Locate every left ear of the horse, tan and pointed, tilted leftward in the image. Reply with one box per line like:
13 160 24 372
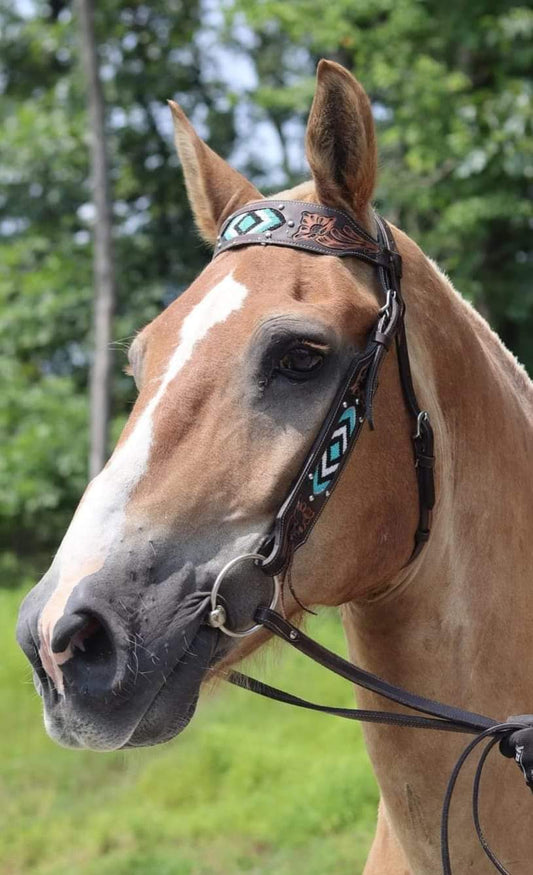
168 100 262 244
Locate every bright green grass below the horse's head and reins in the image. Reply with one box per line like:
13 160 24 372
0 590 377 875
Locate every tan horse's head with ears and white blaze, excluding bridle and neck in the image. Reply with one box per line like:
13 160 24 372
18 62 425 750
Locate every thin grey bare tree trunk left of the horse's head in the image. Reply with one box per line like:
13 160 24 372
78 0 115 478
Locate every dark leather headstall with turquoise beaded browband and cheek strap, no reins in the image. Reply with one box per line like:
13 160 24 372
215 200 435 576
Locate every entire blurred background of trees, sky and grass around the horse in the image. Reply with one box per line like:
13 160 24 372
0 0 533 875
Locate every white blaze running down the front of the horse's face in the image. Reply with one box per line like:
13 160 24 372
39 273 248 692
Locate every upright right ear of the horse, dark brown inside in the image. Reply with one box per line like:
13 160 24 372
306 61 377 215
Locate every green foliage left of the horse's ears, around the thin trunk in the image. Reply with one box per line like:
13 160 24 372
0 0 234 576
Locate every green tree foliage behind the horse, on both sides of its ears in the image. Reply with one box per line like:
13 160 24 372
0 0 533 576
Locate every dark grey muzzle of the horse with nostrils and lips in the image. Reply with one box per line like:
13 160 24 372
17 566 220 750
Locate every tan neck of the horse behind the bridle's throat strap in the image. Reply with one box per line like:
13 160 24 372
344 252 533 872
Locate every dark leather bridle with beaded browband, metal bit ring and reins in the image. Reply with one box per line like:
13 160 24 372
207 200 533 875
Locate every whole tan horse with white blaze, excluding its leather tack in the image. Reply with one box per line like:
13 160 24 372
18 60 533 875
